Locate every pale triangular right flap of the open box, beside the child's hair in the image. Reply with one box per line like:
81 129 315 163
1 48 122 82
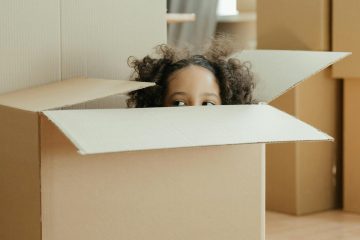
233 50 350 103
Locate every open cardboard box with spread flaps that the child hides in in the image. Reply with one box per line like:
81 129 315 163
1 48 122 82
0 50 347 240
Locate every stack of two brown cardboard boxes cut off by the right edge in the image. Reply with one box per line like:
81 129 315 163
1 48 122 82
332 0 360 213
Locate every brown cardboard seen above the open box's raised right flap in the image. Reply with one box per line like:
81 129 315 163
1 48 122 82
257 0 330 51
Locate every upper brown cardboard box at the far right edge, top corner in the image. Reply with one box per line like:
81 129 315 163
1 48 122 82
332 0 360 78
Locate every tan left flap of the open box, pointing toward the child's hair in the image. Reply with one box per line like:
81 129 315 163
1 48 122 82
0 78 154 112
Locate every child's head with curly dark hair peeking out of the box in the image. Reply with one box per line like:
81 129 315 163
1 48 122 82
128 36 254 107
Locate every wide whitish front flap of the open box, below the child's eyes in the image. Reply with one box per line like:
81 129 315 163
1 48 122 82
44 105 331 154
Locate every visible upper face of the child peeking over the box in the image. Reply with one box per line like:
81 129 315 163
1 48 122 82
164 65 221 107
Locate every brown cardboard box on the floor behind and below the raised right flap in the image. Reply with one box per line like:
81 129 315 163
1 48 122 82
266 69 341 215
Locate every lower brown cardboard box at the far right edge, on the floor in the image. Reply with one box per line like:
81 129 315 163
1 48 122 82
344 79 360 213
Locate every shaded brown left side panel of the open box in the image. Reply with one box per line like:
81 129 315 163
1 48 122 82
0 106 41 240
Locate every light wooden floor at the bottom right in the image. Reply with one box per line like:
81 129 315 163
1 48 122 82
266 211 360 240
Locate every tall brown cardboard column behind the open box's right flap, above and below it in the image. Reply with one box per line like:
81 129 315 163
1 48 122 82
257 0 341 215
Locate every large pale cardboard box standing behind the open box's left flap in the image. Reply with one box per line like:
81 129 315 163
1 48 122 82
0 0 167 109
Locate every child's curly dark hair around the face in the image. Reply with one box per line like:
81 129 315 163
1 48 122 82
127 35 255 107
